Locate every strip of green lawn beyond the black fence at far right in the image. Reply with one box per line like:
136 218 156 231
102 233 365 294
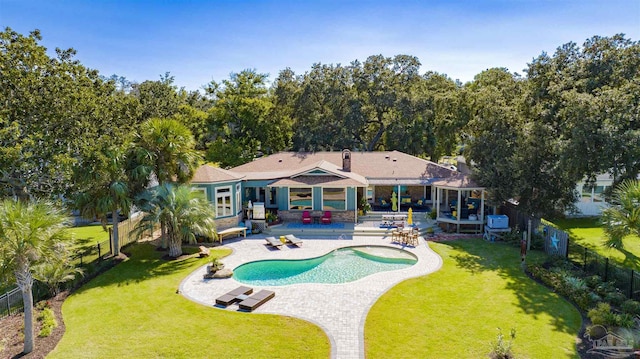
551 217 640 271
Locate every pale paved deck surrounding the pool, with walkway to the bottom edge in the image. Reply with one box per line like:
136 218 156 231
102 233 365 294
180 235 442 359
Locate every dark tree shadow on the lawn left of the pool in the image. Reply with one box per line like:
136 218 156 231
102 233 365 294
70 243 210 294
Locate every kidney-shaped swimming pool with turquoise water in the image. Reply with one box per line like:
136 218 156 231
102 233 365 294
233 246 418 286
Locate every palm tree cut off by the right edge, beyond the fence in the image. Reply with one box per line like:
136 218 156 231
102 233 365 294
602 180 640 249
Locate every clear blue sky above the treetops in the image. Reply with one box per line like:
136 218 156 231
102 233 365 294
0 0 640 90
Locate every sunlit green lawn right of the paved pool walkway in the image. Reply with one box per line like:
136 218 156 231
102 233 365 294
365 239 582 358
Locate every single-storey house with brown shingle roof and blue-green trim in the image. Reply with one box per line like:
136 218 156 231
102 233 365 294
192 150 484 229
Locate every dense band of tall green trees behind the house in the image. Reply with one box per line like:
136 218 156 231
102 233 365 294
0 28 640 215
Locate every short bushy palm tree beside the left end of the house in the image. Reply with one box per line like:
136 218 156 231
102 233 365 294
136 183 216 258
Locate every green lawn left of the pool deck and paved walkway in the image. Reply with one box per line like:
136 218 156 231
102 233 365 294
49 244 331 358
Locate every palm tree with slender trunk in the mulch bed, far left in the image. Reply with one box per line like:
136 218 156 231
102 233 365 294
0 199 69 354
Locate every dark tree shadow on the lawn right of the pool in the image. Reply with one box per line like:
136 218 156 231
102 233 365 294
445 239 580 334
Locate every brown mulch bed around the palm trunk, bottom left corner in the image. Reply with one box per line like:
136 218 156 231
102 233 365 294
0 292 68 359
